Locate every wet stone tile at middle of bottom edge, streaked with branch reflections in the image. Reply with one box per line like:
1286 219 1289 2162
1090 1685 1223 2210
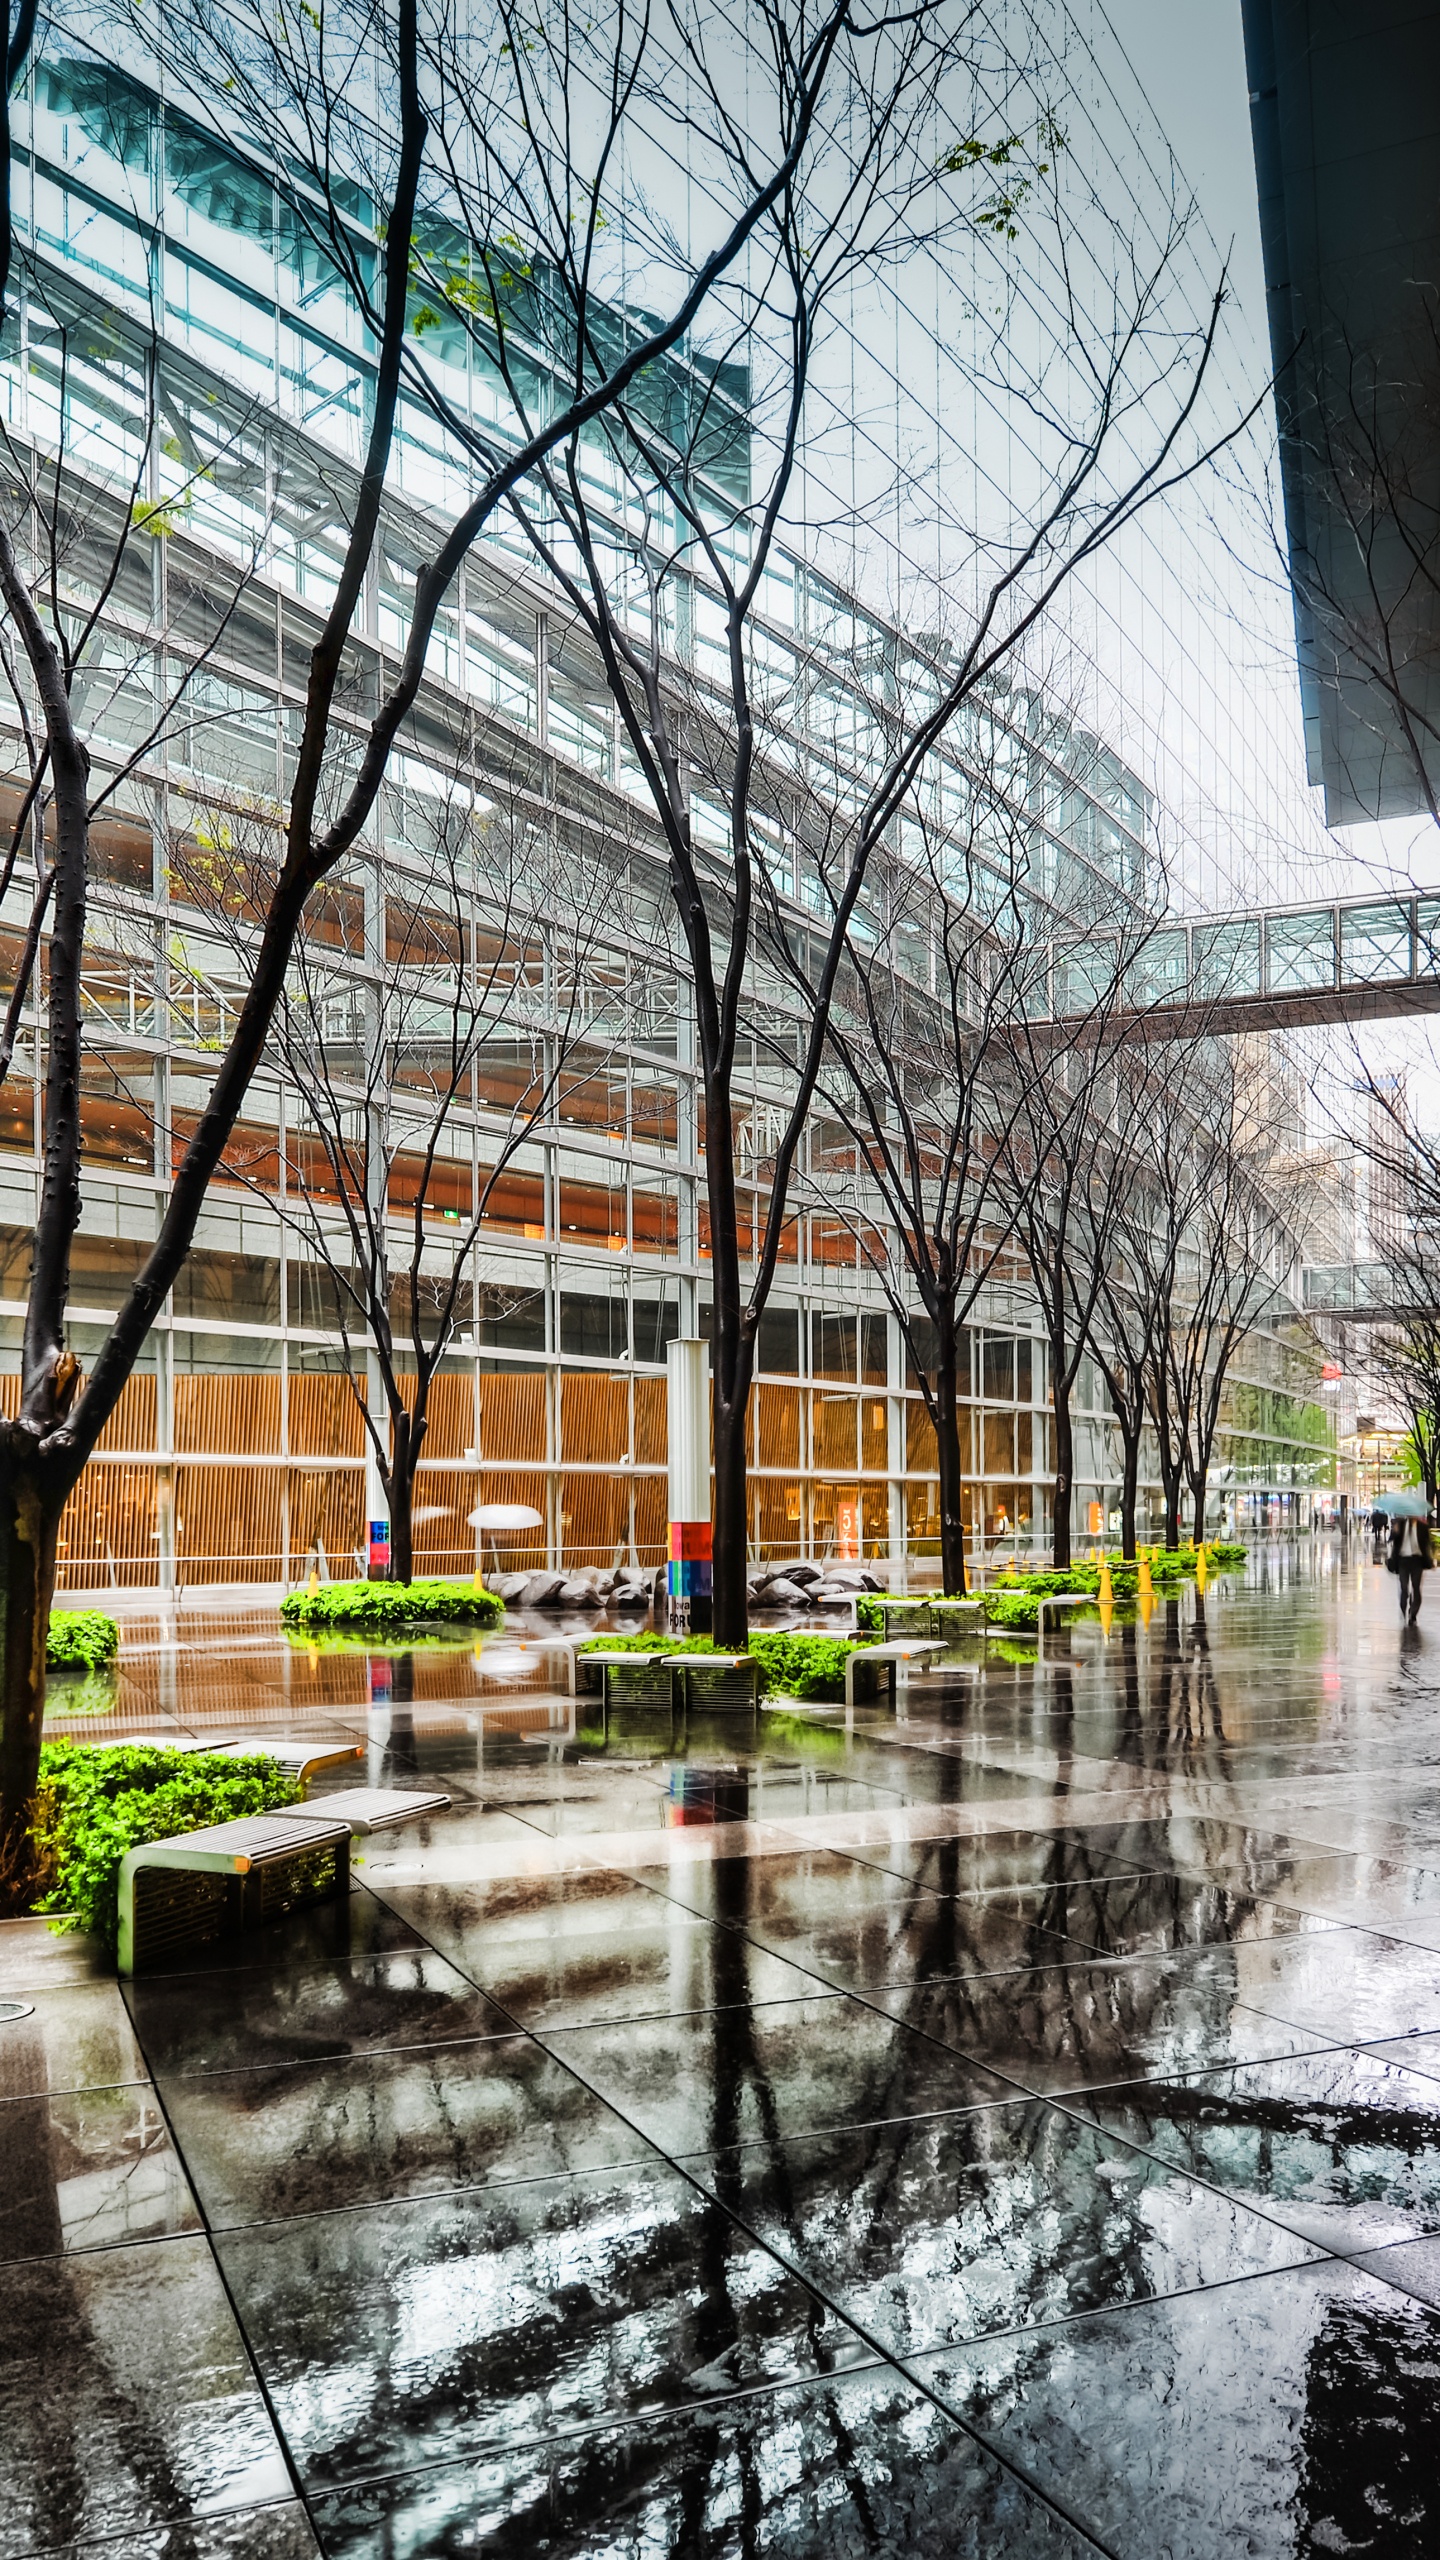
304 2365 1092 2560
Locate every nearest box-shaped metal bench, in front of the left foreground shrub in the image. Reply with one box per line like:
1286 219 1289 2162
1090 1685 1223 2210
118 1807 351 1974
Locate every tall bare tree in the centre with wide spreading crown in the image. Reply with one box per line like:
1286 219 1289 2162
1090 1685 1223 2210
368 0 1245 1644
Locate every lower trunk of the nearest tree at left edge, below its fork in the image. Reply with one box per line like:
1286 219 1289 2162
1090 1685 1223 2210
0 1454 69 1876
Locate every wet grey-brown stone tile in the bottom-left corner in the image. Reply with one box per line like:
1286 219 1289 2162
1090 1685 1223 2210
0 2237 292 2552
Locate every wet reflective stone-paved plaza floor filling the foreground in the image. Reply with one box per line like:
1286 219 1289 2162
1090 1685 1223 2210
0 1544 1440 2560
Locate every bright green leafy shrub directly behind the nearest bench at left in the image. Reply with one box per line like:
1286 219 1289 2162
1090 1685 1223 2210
31 1743 300 1946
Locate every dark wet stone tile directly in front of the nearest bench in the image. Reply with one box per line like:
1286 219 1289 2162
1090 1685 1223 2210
126 1948 507 2079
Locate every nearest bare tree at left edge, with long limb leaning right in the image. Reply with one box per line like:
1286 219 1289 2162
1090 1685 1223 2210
0 0 860 1884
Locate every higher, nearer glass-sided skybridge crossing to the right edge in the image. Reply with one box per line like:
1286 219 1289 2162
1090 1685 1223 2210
1033 896 1440 1039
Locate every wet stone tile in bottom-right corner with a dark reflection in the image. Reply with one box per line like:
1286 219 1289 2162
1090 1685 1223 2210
915 2260 1440 2560
